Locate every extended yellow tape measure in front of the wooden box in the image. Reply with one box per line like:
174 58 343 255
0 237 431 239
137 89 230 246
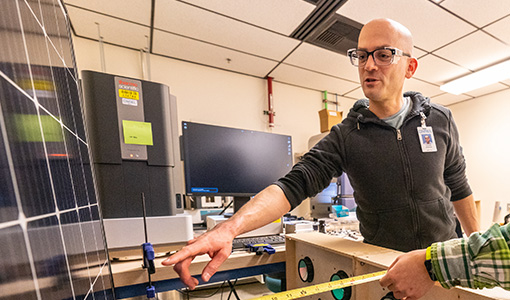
252 271 387 300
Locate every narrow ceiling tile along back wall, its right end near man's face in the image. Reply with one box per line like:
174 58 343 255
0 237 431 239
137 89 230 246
269 64 359 95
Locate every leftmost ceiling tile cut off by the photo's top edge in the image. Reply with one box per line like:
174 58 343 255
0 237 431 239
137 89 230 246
64 0 151 26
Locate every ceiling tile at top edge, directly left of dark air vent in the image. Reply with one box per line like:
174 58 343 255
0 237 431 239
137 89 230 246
178 0 315 36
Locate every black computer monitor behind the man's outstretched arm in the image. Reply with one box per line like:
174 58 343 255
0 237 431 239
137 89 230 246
181 122 292 197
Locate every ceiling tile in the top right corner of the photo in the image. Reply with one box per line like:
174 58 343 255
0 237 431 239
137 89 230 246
441 0 510 27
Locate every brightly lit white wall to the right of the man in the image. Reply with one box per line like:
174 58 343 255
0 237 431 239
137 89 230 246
449 89 510 229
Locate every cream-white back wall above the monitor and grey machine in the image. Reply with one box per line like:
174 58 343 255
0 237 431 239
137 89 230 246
73 37 352 215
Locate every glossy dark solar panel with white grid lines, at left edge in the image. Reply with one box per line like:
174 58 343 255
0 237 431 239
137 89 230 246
0 0 114 299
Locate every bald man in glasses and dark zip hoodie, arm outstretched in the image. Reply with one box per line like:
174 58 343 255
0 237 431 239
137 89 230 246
163 19 478 288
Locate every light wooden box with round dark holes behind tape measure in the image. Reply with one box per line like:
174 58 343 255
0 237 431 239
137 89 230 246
285 232 504 300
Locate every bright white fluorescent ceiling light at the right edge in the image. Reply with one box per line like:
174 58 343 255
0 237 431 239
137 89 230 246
439 60 510 95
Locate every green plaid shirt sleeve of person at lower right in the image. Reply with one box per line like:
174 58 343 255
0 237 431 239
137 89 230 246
430 224 510 290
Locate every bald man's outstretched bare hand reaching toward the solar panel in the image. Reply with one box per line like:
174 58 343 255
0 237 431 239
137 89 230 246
162 224 234 289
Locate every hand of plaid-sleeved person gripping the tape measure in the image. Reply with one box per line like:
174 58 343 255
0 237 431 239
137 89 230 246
379 250 434 300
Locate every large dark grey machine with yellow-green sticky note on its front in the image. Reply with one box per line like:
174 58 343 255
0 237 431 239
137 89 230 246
82 71 183 218
